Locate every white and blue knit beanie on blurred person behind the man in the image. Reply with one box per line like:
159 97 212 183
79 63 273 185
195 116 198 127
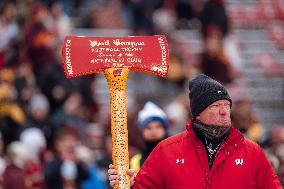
138 102 168 129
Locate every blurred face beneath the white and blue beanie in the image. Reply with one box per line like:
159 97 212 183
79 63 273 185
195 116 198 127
142 121 166 141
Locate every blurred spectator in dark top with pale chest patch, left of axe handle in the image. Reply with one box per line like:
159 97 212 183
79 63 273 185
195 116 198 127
44 128 89 189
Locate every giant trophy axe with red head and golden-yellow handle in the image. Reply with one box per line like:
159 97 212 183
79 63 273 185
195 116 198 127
62 35 169 189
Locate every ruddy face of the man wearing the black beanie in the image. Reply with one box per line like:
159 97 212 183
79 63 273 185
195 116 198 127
196 100 231 126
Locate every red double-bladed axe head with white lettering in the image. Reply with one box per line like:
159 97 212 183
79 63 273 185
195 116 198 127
62 35 169 78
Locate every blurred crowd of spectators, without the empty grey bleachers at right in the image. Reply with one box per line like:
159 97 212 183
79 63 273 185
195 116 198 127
0 0 284 189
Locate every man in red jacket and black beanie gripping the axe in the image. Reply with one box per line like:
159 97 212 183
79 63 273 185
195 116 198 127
109 75 282 189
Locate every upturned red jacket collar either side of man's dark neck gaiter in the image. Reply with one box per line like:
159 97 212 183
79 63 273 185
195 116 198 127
186 119 244 143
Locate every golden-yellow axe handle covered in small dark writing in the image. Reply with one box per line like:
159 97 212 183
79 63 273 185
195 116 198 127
104 68 130 189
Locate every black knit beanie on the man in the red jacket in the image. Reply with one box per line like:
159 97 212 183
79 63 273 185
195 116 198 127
189 74 232 117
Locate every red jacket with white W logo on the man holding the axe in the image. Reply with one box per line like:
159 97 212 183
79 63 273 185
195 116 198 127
133 122 282 189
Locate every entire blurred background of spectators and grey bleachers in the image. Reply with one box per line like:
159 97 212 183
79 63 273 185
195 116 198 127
0 0 284 189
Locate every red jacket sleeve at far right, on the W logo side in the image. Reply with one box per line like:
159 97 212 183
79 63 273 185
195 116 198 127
256 148 282 189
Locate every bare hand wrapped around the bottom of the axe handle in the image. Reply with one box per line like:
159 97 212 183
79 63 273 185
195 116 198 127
108 164 137 187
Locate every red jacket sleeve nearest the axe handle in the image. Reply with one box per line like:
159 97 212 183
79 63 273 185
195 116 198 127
133 145 165 189
